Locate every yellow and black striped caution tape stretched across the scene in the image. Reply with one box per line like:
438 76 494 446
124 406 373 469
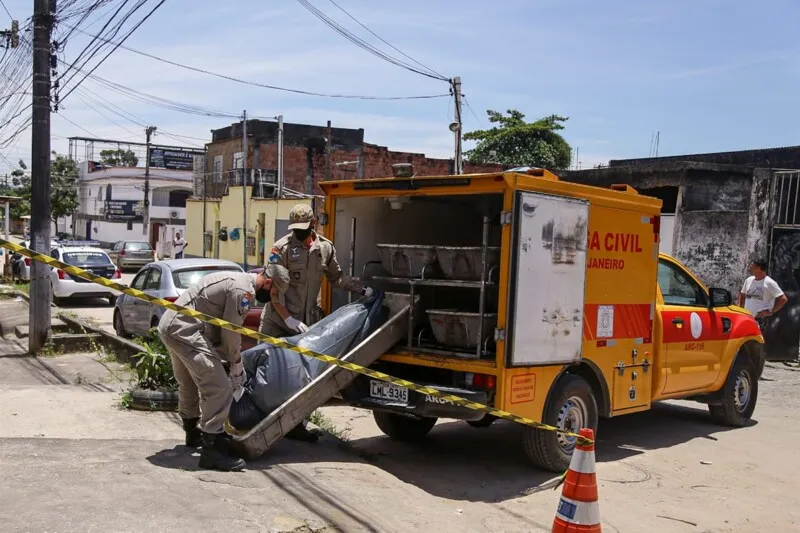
0 239 594 444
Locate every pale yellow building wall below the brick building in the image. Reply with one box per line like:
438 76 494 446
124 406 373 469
185 187 311 268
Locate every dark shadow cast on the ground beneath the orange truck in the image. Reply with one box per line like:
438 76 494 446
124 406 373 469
148 404 756 503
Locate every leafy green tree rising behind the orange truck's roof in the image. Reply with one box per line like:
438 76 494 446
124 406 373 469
464 109 572 170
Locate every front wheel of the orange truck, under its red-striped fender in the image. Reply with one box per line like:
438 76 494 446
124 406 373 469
708 360 758 427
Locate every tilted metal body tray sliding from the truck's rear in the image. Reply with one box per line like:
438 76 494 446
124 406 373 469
228 293 410 459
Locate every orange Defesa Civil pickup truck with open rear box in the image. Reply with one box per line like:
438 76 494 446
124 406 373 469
320 169 764 471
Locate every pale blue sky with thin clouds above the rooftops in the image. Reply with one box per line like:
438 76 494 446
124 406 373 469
0 0 800 171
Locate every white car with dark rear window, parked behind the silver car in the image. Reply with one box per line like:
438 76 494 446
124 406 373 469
50 246 122 306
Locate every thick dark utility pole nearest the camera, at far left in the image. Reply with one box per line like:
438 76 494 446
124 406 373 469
28 0 55 354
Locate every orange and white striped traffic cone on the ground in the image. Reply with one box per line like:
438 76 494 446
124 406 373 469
551 428 601 533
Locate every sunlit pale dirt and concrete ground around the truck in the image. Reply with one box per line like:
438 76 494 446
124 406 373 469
0 332 800 533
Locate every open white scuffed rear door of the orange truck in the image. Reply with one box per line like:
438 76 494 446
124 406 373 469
506 192 589 367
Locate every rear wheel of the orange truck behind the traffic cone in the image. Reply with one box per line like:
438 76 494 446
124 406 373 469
522 374 598 472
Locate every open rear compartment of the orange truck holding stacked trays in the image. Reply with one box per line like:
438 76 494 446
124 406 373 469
331 194 503 412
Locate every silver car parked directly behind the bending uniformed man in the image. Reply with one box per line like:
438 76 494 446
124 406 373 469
114 258 243 337
